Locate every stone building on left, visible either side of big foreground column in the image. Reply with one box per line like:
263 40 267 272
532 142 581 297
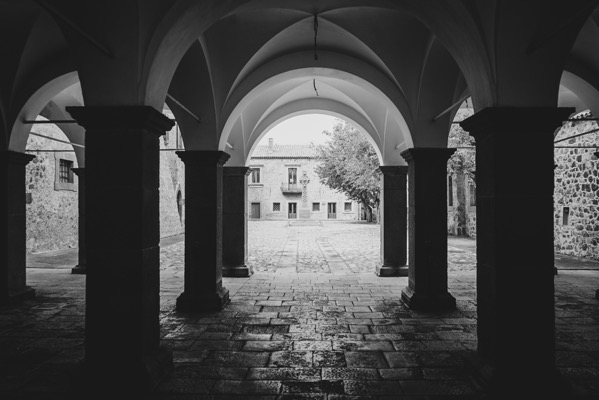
25 110 185 253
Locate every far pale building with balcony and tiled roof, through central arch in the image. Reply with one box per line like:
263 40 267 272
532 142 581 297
248 139 360 220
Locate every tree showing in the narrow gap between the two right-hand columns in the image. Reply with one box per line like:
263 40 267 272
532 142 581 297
447 109 476 236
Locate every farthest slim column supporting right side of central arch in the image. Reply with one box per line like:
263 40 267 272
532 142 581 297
375 166 408 276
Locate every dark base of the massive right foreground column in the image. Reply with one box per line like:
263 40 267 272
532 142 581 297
464 352 572 399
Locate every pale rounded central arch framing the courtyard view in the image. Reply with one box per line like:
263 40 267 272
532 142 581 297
219 68 413 165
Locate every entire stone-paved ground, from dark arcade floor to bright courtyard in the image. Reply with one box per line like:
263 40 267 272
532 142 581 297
0 221 599 400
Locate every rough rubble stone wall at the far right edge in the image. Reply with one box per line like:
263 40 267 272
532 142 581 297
554 112 599 259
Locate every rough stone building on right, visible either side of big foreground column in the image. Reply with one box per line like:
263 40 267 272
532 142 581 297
447 111 599 260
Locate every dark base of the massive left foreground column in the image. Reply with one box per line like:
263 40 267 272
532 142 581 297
73 346 174 395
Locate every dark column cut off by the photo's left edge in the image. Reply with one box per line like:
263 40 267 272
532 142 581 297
0 151 35 305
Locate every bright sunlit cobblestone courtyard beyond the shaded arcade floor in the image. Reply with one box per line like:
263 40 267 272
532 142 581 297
248 221 476 275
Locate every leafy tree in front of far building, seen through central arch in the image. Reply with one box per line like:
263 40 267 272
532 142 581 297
316 120 380 222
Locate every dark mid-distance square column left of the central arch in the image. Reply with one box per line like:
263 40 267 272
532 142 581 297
177 150 229 312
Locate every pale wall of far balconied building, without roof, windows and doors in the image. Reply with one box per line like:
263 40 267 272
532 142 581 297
248 158 359 220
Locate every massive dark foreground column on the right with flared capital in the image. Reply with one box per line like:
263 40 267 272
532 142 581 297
460 107 574 393
